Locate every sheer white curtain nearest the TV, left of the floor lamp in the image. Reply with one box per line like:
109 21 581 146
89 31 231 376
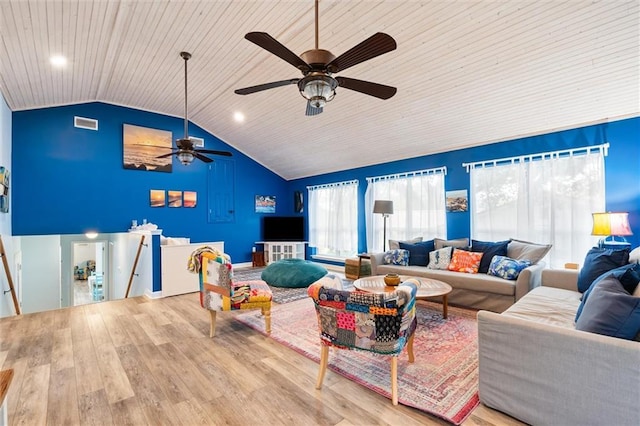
307 180 358 258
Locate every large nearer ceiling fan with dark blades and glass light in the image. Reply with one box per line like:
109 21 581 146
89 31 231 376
235 0 396 116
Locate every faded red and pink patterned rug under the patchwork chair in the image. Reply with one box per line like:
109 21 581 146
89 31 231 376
235 298 479 425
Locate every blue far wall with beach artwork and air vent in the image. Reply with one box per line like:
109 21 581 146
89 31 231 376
11 103 293 262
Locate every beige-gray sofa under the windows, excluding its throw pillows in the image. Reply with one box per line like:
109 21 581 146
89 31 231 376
371 239 549 313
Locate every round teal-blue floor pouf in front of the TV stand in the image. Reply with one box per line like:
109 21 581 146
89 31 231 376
262 259 327 288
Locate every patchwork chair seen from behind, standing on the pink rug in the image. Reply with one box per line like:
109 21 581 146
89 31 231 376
308 280 417 405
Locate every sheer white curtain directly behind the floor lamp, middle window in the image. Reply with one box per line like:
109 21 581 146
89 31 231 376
365 167 447 252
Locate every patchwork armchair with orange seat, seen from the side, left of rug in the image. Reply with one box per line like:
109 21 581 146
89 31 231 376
198 250 273 337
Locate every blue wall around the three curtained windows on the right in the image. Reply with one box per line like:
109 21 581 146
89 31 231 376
289 118 640 252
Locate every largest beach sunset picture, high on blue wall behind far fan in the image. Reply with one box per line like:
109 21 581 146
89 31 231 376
122 124 173 173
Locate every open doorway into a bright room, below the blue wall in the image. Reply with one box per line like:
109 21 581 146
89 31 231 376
71 241 109 306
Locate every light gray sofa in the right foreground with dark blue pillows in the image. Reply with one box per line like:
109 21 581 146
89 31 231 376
478 269 640 426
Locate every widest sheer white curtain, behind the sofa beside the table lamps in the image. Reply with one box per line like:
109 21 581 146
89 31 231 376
465 145 608 268
